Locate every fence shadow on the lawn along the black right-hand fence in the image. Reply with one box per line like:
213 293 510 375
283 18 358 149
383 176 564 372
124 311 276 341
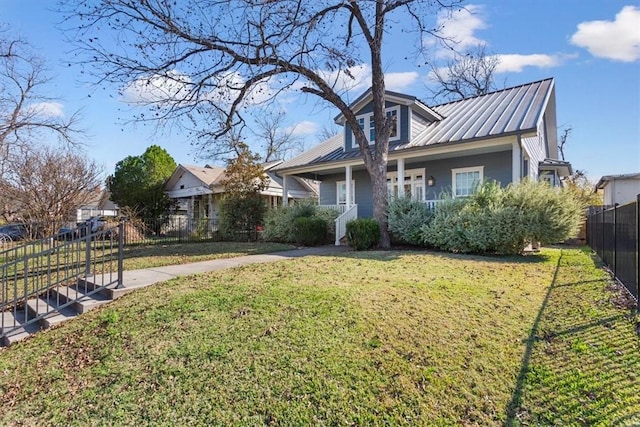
505 252 640 426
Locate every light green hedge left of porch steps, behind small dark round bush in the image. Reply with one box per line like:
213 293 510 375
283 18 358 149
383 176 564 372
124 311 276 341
262 201 339 243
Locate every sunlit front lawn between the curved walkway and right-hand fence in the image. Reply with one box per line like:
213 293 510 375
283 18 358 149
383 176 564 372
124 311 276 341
0 249 640 426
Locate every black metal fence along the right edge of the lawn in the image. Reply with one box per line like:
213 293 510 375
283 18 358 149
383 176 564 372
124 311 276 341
587 194 640 308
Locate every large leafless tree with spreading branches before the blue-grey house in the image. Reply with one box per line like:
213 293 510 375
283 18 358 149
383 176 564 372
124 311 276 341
63 0 460 247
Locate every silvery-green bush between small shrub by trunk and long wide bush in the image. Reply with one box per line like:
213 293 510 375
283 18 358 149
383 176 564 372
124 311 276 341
388 197 434 245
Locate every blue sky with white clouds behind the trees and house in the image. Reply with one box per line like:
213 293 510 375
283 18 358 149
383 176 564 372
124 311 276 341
0 0 640 181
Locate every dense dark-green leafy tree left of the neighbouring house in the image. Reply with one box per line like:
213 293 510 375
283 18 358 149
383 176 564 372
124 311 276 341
107 145 176 218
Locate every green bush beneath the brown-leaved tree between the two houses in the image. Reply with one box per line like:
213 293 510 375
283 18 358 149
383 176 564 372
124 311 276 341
219 195 267 241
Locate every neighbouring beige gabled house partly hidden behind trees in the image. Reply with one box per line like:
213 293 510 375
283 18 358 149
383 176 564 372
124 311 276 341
165 161 318 224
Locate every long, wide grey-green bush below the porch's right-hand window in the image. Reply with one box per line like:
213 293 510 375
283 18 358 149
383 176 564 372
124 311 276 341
420 180 582 254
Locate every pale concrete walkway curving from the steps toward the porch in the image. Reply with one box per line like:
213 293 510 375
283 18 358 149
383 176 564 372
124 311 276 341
110 246 351 298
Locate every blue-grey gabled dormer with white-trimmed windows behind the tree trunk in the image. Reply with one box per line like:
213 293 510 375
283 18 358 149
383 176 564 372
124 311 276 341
334 89 443 151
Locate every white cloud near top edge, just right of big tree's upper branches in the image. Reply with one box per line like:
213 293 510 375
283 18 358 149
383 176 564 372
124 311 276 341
437 4 487 54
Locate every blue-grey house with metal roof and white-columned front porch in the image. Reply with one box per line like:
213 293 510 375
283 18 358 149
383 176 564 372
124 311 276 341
274 79 572 244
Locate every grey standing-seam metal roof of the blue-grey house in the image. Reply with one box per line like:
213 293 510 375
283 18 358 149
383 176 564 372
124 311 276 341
274 79 554 170
